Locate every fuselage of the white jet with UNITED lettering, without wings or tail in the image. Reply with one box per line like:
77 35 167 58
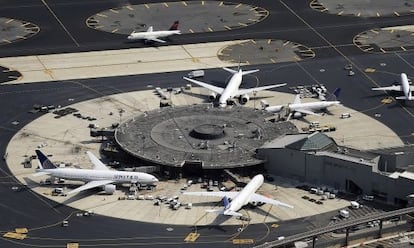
38 168 158 184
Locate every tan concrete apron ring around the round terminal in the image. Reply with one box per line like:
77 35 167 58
7 87 402 225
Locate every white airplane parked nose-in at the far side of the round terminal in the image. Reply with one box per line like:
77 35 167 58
184 68 286 107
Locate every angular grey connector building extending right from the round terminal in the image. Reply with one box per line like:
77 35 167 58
257 132 414 206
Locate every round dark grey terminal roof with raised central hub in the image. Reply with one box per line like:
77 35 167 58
115 104 298 169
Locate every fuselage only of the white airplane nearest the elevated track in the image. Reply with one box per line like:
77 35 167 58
224 174 264 215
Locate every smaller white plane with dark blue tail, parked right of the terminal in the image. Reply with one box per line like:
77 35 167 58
264 88 341 119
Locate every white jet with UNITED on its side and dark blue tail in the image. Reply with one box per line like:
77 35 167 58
35 150 158 194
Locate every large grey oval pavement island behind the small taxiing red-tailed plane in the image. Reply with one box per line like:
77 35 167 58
86 1 269 35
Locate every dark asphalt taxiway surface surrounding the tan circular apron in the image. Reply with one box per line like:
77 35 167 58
0 0 414 247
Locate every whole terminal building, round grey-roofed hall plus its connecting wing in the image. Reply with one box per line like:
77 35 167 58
115 104 414 206
